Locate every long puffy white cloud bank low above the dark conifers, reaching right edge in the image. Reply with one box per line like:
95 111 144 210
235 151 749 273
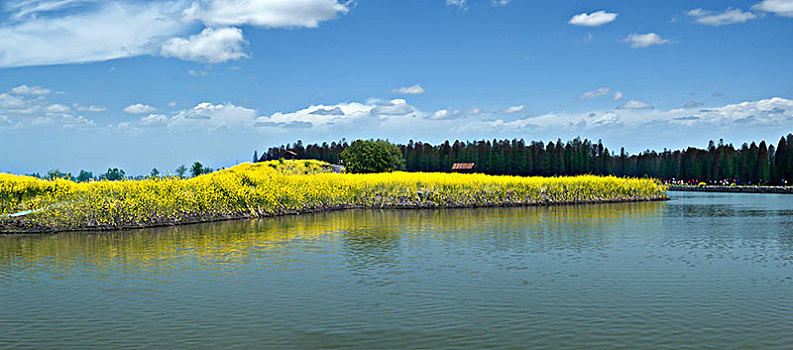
183 97 793 137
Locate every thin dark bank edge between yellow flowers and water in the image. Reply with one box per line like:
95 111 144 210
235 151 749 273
0 196 669 235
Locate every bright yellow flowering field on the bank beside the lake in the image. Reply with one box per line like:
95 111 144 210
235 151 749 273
0 160 668 233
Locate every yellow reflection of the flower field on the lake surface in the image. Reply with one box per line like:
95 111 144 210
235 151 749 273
0 202 664 270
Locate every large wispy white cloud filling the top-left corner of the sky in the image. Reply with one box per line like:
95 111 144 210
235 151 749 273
0 1 189 67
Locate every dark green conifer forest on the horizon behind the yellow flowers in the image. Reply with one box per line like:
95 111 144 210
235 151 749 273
254 134 793 185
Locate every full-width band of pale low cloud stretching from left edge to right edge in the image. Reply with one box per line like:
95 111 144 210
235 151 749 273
7 89 793 156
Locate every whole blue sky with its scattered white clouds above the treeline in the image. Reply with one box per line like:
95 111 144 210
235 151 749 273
0 0 793 174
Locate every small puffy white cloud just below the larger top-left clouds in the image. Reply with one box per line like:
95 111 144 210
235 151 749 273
160 28 248 63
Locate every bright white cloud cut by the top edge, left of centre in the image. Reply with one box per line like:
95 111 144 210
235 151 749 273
184 0 349 28
